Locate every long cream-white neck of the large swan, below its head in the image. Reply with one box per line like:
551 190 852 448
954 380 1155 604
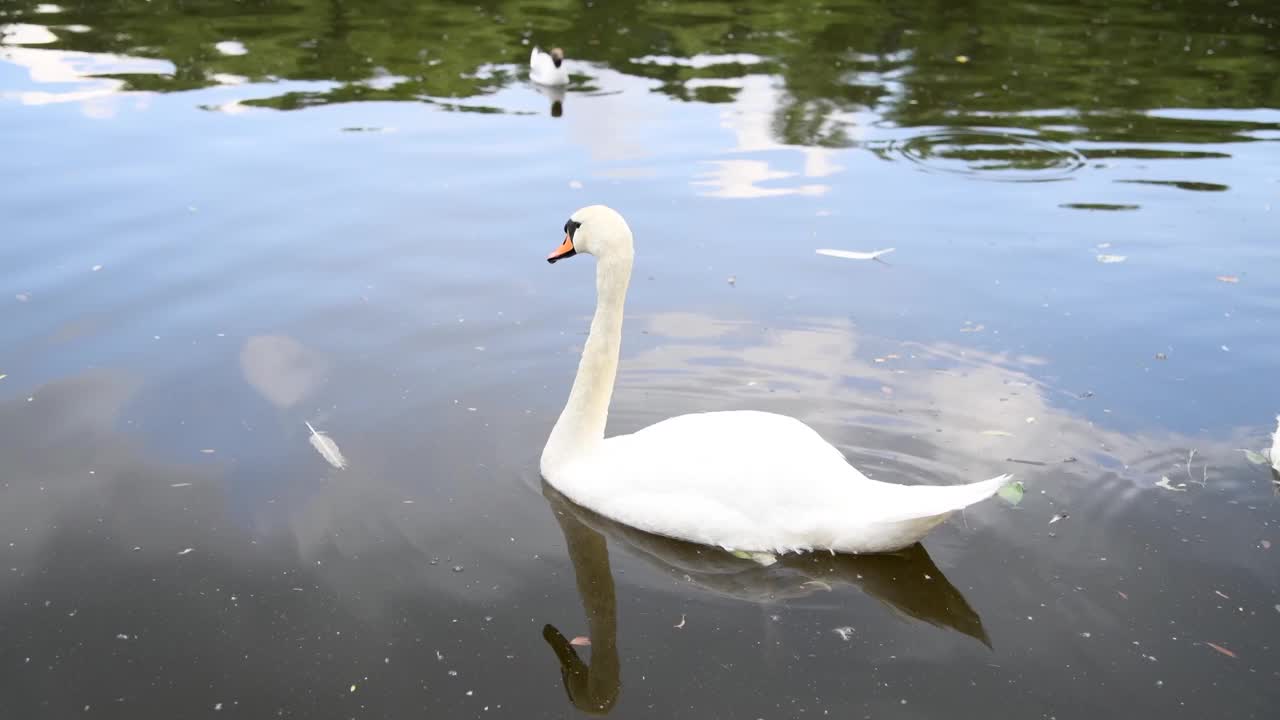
543 255 632 470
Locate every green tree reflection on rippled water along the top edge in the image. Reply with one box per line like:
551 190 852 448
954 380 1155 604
12 0 1280 145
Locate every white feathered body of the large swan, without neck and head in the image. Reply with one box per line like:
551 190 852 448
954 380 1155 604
548 411 1005 552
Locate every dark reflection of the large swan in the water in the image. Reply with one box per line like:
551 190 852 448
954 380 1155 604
543 482 991 715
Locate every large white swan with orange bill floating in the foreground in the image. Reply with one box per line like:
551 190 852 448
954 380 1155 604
541 205 1010 552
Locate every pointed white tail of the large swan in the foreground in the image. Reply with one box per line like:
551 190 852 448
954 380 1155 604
835 475 1012 552
